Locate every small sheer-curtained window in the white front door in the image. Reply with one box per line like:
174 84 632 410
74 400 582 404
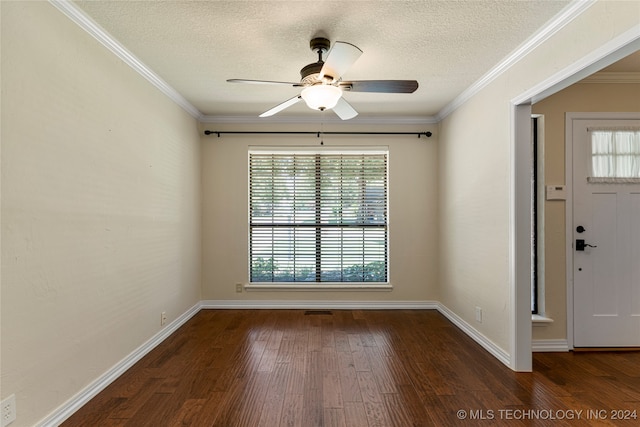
589 128 640 182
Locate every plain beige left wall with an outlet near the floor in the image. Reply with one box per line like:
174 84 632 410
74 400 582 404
1 2 200 427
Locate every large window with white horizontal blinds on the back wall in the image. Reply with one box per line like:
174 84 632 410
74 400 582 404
249 150 388 283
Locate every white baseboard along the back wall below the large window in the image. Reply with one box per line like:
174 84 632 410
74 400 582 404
200 300 439 310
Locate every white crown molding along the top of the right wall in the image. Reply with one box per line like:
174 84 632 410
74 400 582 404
436 0 597 121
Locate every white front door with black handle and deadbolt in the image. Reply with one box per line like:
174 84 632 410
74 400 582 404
568 119 640 347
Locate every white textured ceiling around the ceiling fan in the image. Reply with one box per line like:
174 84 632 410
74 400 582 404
75 0 569 118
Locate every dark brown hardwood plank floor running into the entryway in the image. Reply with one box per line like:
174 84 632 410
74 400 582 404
63 310 640 427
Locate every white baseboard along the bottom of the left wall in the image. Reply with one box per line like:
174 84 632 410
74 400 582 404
36 303 201 427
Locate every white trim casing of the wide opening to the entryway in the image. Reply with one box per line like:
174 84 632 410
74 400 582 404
509 29 640 372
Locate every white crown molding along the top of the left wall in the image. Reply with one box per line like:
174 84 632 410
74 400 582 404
49 0 202 119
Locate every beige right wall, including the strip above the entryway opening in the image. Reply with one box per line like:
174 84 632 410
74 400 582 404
438 1 640 354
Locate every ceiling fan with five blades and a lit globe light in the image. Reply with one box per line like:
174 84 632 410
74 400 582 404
227 37 418 120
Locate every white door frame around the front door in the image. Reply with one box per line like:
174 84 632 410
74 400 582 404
564 112 640 350
